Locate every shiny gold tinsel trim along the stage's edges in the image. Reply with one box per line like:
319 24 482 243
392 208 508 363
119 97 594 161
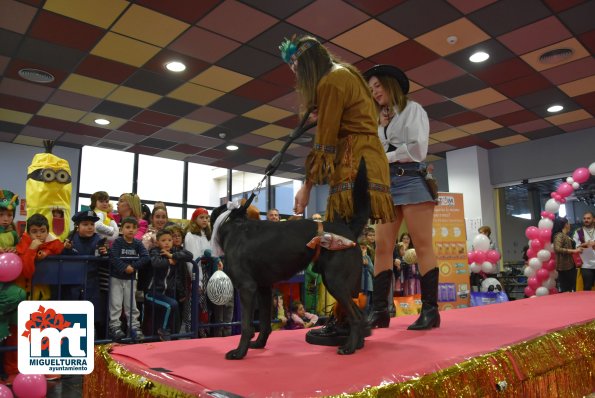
83 322 595 398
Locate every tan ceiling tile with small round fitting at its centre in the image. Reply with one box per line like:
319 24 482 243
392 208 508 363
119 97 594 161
415 18 490 56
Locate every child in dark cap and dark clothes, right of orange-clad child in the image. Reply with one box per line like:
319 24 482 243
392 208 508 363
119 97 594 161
62 210 108 330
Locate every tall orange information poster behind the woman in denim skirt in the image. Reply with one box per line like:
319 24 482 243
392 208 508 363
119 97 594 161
432 192 470 310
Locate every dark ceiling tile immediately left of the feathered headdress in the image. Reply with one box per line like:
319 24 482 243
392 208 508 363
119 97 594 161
217 46 283 77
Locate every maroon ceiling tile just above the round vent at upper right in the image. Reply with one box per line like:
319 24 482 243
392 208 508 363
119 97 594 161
498 16 572 55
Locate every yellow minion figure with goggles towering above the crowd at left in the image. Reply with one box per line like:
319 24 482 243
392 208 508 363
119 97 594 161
26 141 72 241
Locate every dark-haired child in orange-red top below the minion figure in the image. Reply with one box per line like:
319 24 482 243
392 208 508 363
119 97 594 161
16 214 64 300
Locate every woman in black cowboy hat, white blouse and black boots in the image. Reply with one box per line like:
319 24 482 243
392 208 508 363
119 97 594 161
364 65 440 330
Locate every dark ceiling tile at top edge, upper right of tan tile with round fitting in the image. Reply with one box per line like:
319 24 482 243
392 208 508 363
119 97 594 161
468 0 551 36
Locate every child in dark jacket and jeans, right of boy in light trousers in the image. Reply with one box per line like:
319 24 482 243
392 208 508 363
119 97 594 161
144 229 192 340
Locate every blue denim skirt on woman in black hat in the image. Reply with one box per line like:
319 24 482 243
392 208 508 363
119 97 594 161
389 162 434 206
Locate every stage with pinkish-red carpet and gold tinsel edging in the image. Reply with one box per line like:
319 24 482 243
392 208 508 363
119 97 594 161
84 292 595 397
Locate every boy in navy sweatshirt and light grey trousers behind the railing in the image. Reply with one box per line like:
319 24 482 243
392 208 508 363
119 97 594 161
109 217 151 340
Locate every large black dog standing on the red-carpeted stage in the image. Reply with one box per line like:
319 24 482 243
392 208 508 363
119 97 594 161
211 158 370 359
